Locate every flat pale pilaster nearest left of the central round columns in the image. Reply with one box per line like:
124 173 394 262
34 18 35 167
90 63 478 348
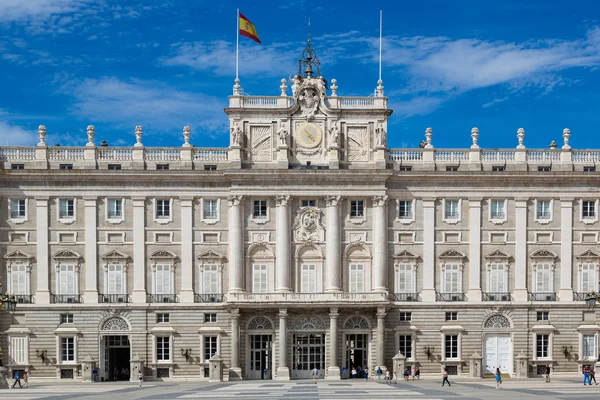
179 198 194 303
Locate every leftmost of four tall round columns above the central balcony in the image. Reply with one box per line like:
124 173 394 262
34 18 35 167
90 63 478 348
227 195 244 293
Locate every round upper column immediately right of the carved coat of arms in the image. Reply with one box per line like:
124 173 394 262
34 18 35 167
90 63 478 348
325 196 342 292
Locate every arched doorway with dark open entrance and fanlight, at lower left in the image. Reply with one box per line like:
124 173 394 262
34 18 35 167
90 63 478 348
99 316 131 381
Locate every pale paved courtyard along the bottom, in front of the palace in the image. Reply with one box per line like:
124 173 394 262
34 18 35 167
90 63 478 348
0 379 600 400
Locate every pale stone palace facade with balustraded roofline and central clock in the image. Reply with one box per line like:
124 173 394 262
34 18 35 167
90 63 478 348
0 47 600 380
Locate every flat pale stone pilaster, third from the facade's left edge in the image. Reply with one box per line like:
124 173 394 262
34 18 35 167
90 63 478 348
131 197 146 303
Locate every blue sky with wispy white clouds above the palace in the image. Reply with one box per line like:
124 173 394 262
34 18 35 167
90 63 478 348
0 0 600 148
